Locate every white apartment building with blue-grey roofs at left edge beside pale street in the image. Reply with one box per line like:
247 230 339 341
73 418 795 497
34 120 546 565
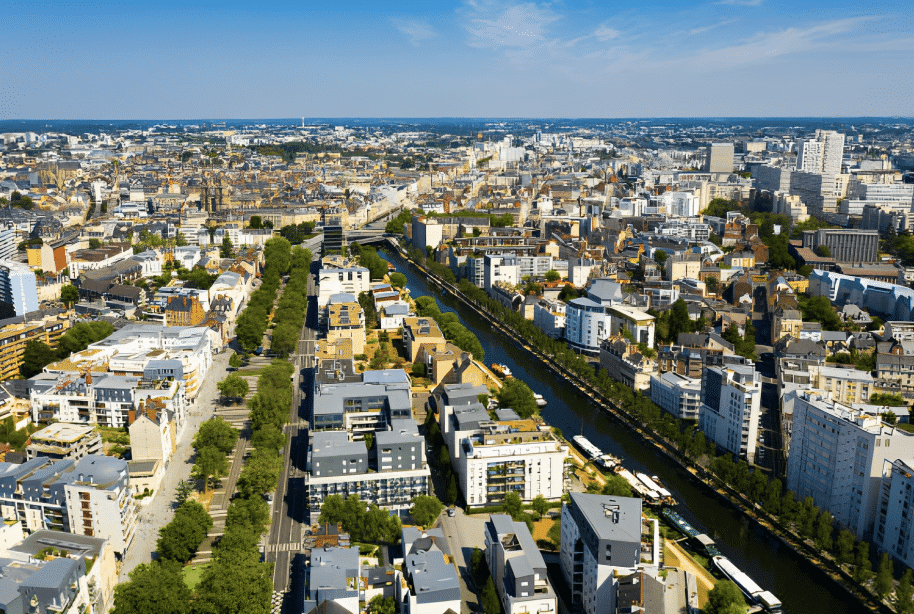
0 455 138 555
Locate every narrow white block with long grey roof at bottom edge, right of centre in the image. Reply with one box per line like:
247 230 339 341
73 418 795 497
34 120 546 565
485 514 556 614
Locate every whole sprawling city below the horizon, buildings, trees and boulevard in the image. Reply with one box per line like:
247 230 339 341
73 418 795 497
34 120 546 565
0 117 914 614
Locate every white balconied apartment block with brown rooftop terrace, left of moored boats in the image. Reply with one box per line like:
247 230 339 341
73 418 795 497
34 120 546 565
439 384 568 505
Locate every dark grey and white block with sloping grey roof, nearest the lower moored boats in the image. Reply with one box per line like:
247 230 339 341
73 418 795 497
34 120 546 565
559 492 642 614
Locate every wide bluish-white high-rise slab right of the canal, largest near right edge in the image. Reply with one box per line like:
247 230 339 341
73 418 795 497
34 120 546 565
786 390 914 540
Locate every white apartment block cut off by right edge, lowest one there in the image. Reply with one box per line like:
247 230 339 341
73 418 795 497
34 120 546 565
873 457 914 567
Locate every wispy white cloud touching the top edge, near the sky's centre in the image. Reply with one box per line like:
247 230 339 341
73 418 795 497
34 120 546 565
466 3 559 49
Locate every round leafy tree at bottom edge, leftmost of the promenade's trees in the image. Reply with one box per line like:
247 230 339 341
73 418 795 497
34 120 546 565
111 560 191 614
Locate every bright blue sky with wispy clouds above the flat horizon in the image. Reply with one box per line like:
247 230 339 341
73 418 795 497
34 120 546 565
0 0 914 119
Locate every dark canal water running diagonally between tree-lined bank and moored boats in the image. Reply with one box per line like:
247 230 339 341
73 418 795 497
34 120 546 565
381 252 861 614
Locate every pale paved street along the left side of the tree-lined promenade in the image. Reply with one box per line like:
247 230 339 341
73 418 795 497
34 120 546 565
120 351 231 582
